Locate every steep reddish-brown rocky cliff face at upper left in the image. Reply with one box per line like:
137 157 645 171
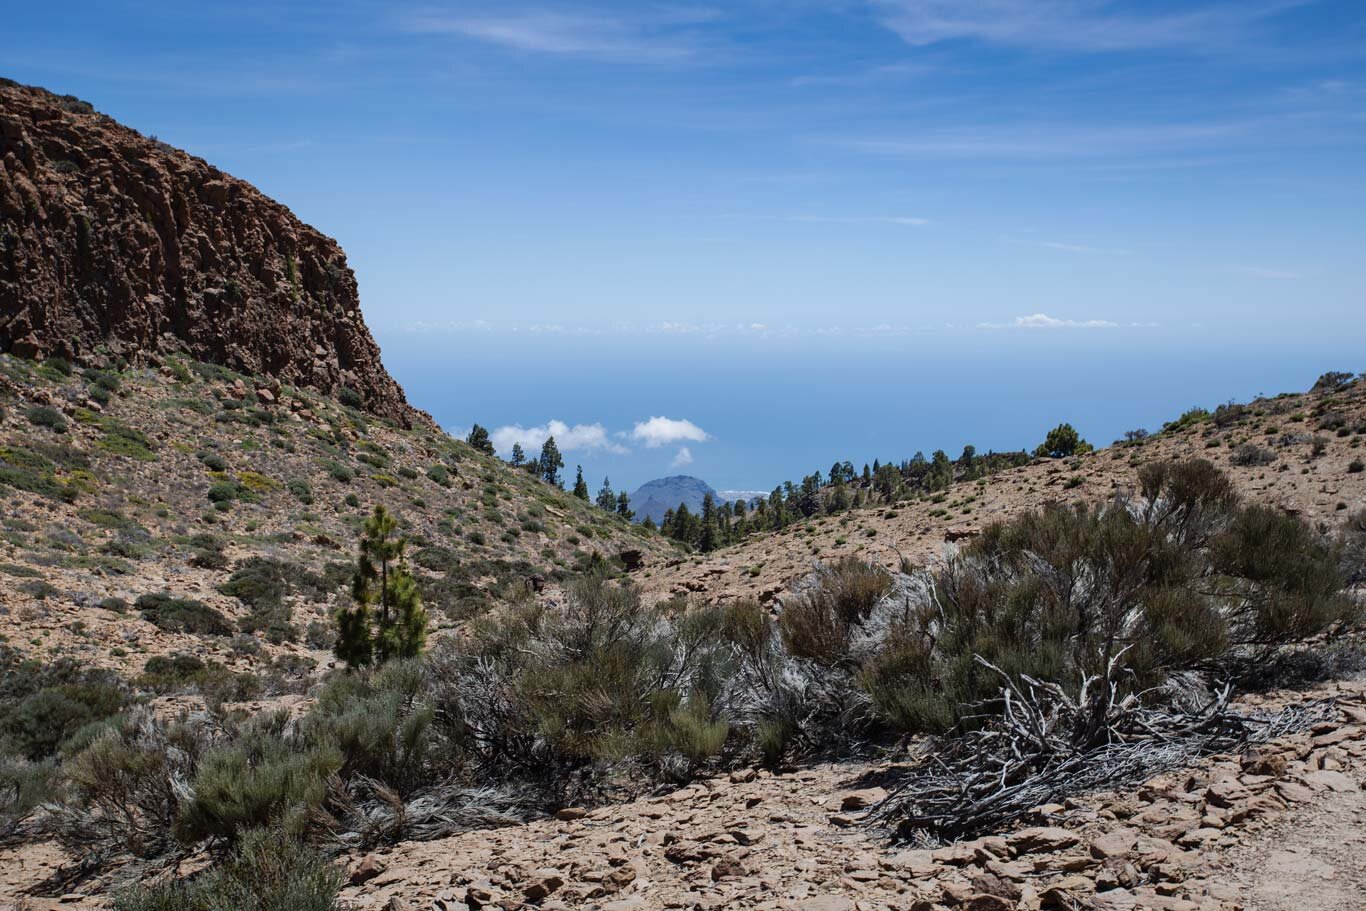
0 82 430 425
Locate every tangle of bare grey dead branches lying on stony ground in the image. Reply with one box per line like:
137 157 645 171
869 653 1332 843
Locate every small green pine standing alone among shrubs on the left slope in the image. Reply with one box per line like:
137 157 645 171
335 505 428 668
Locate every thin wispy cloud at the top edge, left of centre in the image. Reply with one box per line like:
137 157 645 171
403 10 714 63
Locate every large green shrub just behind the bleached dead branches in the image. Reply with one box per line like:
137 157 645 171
863 460 1355 731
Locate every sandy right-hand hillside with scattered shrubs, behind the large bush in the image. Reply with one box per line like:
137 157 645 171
639 372 1366 604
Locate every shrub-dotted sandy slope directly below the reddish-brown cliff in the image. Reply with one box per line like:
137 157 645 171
0 355 671 675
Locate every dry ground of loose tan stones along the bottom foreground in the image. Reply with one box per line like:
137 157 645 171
307 680 1366 911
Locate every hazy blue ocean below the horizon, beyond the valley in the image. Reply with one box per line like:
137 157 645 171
376 328 1366 496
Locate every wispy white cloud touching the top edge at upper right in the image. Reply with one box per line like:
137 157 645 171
873 0 1306 52
